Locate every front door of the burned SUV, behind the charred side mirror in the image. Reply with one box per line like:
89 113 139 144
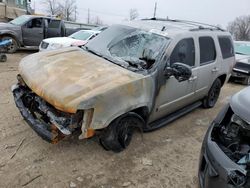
150 38 197 122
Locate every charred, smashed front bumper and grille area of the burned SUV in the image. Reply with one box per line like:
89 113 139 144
12 75 83 144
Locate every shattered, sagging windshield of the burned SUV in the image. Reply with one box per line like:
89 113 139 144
85 25 170 71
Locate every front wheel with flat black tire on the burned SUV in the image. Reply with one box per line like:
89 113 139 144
99 112 144 153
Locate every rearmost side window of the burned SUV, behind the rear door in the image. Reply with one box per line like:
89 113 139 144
219 37 234 59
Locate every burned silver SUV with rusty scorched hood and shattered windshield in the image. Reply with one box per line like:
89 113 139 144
12 19 235 152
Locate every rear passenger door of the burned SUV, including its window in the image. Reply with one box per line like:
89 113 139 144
195 35 221 99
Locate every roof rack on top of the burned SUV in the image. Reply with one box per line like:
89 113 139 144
142 18 225 31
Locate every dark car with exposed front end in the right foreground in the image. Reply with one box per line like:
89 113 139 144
198 87 250 188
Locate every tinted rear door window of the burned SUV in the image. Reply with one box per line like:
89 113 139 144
199 37 216 65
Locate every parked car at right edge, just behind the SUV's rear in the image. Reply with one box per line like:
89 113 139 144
231 41 250 85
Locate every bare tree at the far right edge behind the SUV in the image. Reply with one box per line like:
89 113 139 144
227 15 250 41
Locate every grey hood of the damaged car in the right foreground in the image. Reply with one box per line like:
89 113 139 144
230 87 250 123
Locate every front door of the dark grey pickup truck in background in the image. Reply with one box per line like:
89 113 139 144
22 18 44 46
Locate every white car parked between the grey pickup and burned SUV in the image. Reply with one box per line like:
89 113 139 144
39 30 100 51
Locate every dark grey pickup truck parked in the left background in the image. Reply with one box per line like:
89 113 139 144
0 15 94 53
